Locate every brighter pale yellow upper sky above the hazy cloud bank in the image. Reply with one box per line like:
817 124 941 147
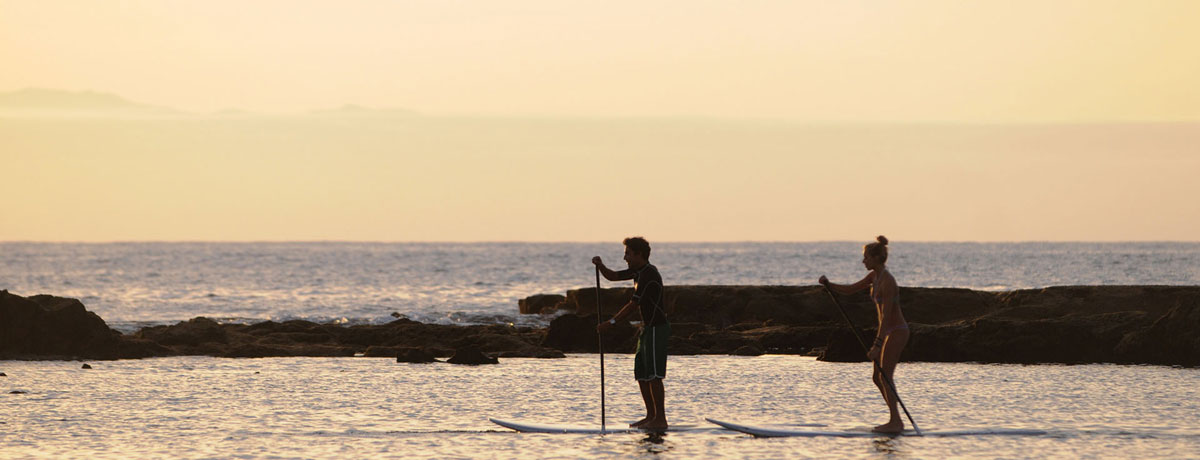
0 0 1200 123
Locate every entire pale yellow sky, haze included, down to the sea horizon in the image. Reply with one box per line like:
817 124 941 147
0 0 1200 241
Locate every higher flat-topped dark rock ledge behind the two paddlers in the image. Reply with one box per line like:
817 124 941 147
544 286 1200 366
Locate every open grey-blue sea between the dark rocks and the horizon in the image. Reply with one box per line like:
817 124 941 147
0 241 1200 331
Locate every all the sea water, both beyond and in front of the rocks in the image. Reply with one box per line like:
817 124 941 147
0 241 1200 459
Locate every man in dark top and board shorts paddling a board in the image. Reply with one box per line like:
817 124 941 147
592 237 671 430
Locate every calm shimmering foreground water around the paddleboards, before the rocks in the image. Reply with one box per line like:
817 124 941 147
0 354 1200 459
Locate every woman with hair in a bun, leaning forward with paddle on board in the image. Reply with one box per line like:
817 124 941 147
817 235 908 432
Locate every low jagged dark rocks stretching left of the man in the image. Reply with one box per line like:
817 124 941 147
0 291 563 364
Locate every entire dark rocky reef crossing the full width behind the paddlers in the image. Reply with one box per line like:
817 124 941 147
0 286 1200 366
